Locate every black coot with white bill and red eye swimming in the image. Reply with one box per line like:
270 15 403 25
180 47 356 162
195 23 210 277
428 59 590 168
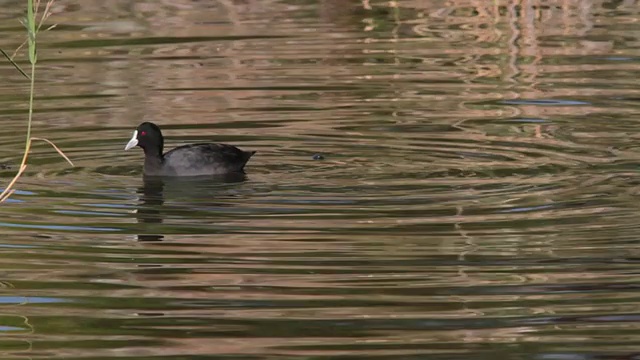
124 122 256 176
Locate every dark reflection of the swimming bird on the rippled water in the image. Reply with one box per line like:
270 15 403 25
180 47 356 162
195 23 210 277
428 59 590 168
136 173 247 241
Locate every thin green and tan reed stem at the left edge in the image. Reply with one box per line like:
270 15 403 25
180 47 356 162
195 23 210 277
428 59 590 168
0 0 73 202
